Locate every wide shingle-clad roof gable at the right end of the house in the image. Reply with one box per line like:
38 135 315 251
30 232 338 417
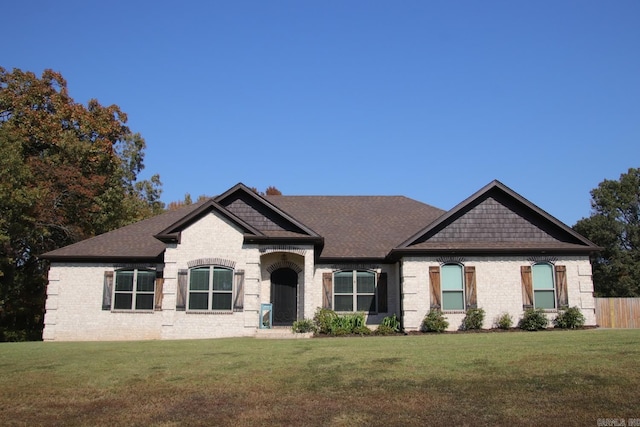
398 181 598 252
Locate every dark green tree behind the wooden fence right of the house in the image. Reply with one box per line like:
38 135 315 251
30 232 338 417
574 168 640 297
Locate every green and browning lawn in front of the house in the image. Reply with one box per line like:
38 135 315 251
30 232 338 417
0 330 640 426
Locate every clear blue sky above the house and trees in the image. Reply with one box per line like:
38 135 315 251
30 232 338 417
0 0 640 225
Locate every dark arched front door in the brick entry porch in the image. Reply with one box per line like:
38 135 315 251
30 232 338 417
271 268 298 325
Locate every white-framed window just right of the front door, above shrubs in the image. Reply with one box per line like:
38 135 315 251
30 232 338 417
333 270 376 312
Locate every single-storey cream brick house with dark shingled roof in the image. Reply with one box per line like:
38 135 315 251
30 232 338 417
43 181 599 340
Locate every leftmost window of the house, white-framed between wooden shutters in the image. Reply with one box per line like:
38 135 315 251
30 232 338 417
113 269 156 310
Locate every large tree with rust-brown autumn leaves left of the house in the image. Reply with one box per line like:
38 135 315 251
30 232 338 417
0 67 164 341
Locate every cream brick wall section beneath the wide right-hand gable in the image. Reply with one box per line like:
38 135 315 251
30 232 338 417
402 256 596 330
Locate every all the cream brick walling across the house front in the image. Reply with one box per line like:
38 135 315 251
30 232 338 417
43 212 596 340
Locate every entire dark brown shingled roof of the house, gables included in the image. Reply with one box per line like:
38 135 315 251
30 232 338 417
43 181 600 262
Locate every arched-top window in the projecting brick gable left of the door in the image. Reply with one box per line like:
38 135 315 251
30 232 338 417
188 266 233 310
